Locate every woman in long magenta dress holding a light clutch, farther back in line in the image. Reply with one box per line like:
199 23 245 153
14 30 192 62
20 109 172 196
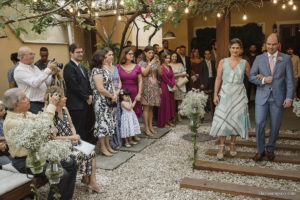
157 52 176 127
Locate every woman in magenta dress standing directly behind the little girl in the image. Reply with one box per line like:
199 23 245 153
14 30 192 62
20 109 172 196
117 47 143 141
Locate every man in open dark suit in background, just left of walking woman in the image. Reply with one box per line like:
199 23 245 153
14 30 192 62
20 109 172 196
199 49 217 90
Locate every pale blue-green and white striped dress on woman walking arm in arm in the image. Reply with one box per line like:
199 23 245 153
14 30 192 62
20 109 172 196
210 58 251 139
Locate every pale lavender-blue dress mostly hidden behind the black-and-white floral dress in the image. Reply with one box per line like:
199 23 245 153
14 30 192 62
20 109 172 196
108 66 122 148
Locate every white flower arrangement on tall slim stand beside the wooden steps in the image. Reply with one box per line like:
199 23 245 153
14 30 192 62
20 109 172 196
179 89 208 169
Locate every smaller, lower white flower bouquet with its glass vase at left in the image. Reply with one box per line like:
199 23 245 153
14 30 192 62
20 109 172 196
40 140 72 184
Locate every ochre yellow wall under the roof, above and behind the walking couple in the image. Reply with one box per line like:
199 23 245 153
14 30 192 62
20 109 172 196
163 2 300 54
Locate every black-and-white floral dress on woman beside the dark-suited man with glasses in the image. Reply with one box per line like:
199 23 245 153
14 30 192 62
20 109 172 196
90 68 117 138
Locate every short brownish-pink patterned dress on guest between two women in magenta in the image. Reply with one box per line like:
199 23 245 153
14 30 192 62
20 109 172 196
139 60 160 106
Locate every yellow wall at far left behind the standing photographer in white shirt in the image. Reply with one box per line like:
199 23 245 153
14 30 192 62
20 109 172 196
0 23 69 98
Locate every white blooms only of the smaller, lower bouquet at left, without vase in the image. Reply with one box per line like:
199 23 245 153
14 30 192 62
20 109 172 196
40 140 72 162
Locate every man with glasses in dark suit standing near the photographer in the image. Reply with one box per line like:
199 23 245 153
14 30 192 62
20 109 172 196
64 44 92 140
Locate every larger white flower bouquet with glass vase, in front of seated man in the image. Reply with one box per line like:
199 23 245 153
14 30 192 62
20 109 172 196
8 113 52 174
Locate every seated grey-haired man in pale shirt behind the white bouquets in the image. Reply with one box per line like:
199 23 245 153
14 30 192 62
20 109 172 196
3 88 77 200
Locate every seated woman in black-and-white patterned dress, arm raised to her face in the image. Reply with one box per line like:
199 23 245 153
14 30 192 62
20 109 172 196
45 86 100 193
